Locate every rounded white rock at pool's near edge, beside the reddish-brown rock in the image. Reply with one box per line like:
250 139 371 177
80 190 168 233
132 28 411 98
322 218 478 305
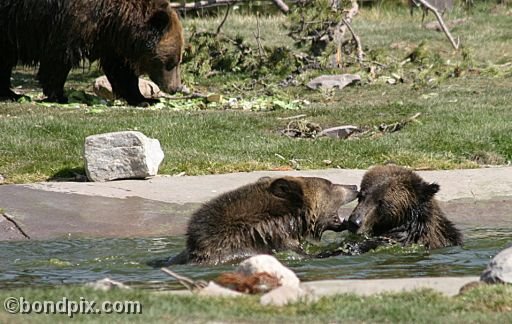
237 254 300 287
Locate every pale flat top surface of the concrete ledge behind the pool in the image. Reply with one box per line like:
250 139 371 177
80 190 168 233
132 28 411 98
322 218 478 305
24 167 512 204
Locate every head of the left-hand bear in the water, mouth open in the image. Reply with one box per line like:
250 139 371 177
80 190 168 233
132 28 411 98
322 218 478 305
270 177 357 239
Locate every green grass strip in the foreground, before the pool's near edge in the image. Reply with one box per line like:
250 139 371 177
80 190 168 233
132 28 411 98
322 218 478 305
0 286 512 323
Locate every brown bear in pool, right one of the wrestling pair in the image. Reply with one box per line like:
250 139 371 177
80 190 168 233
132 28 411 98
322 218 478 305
347 165 462 252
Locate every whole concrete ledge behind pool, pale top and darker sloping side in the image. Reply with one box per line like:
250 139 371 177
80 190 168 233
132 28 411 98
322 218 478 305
0 167 512 240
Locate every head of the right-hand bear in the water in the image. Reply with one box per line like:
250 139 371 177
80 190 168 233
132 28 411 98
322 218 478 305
347 165 439 236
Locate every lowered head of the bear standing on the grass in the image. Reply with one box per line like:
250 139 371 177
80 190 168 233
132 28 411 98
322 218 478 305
138 0 184 93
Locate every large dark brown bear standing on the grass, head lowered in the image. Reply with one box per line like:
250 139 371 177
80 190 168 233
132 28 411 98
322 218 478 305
0 0 183 106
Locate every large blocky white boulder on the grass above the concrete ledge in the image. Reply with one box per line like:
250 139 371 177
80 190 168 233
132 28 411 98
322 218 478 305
84 131 164 181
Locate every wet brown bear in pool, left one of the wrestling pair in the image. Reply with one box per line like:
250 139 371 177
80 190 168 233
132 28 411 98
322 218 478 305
168 177 357 264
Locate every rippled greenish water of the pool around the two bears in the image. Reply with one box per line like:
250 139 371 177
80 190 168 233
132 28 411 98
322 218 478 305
0 227 512 289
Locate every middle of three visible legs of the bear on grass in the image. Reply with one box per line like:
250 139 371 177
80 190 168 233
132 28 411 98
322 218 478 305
37 60 71 103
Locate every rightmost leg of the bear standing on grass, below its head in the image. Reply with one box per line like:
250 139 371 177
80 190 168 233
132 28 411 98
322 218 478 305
101 57 158 106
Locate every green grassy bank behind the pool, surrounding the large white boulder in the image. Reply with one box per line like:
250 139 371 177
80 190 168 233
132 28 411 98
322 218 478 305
0 4 512 183
